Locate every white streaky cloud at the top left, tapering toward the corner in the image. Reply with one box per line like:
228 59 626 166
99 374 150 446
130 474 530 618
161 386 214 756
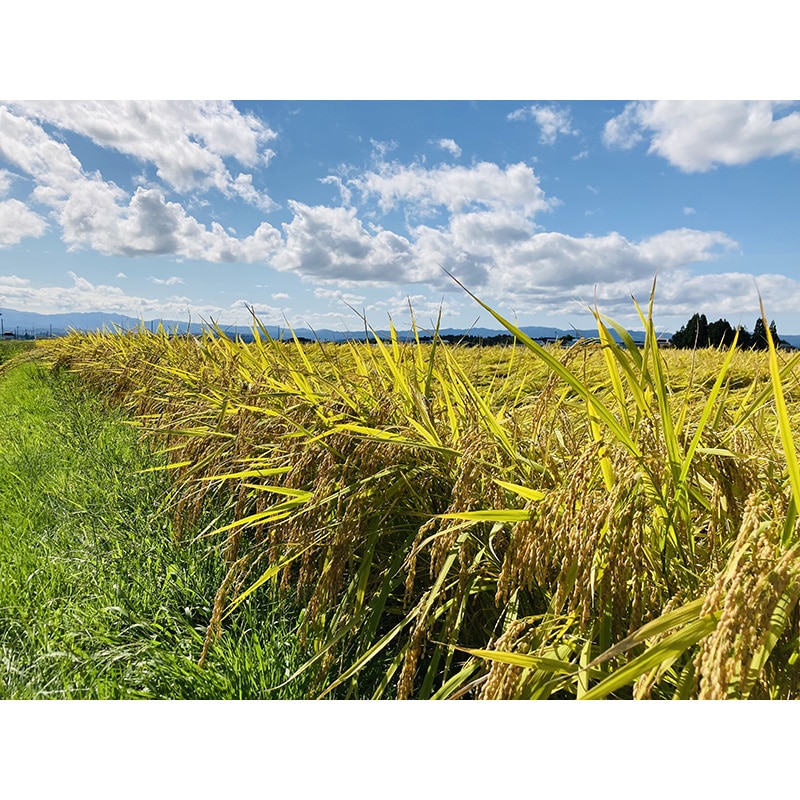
13 101 276 208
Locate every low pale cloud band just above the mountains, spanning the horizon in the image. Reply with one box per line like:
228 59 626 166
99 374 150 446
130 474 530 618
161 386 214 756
0 266 800 330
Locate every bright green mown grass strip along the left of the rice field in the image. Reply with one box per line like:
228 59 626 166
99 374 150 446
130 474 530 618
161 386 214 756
0 360 308 699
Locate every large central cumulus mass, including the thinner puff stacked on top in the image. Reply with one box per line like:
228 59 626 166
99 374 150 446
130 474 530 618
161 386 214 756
272 148 738 304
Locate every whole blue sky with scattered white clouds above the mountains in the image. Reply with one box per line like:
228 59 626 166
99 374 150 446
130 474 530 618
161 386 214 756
0 99 800 334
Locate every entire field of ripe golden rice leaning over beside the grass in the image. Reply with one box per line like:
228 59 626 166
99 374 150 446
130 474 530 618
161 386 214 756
37 290 800 699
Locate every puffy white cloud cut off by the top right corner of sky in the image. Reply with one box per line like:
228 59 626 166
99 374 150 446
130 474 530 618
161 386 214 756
603 100 800 172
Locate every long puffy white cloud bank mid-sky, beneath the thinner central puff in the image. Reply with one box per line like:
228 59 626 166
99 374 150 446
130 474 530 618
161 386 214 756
273 203 738 311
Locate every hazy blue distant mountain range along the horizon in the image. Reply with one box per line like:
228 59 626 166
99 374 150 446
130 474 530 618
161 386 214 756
0 308 800 347
